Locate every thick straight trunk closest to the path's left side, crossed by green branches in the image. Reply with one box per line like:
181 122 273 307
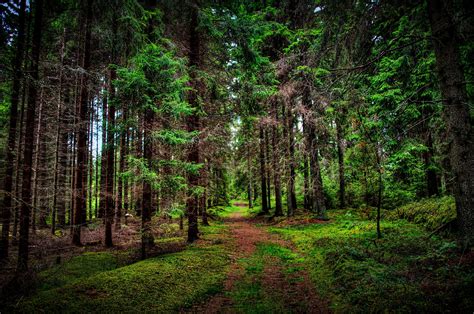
186 1 201 242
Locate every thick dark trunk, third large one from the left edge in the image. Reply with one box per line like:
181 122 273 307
72 0 92 245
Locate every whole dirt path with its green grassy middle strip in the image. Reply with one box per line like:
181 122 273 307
186 203 328 313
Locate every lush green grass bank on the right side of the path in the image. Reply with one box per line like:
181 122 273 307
270 211 474 312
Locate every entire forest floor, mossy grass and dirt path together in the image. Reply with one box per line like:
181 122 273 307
0 202 474 313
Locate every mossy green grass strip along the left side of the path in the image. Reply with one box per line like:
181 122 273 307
7 225 230 313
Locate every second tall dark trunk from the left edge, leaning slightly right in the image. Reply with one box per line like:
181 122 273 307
17 0 43 272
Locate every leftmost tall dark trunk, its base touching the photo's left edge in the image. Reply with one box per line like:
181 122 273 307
0 0 26 260
